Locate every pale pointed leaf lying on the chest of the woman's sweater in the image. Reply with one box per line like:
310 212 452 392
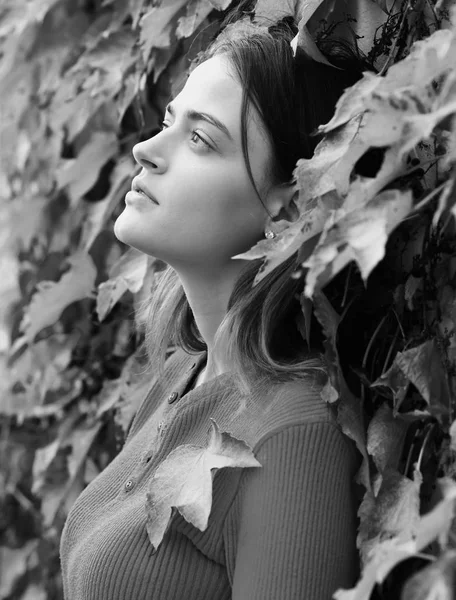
146 419 261 551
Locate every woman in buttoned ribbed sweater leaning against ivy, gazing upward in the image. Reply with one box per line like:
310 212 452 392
61 10 366 600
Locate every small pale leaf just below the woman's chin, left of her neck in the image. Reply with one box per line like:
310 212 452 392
97 248 148 321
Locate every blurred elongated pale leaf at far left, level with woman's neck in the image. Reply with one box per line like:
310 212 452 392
20 252 97 342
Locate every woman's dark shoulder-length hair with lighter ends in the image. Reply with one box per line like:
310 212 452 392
138 11 374 392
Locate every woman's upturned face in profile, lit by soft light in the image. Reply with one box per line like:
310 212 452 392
114 55 271 267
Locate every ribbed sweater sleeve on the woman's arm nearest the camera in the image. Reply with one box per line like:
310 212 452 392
228 422 359 600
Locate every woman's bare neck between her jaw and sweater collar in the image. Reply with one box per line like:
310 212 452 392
173 259 248 381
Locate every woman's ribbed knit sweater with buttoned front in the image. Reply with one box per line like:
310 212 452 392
60 349 359 600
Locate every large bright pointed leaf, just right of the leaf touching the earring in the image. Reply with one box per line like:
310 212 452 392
303 190 412 297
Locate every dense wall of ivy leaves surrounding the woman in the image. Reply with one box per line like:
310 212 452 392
0 0 456 600
